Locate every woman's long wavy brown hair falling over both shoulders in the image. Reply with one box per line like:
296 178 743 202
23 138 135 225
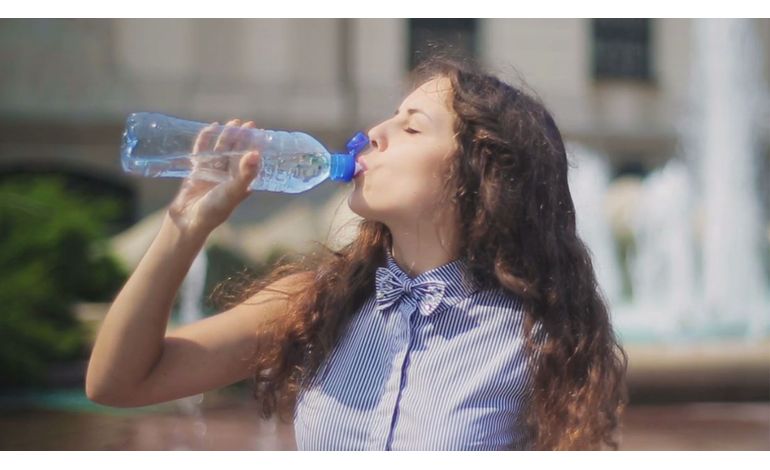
214 57 628 450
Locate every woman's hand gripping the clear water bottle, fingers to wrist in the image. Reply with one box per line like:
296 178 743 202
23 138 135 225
168 119 261 238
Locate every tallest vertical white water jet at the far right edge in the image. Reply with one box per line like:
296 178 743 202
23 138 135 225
688 19 770 339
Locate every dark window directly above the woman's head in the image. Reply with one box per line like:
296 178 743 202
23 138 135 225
409 18 477 69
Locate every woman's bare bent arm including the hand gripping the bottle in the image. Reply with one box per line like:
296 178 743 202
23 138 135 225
86 120 283 406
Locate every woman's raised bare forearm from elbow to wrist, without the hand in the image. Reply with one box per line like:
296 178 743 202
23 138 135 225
86 215 206 398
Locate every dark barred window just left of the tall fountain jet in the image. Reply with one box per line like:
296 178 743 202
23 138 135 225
592 18 652 81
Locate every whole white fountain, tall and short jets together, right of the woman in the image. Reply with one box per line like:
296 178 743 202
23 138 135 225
568 19 770 345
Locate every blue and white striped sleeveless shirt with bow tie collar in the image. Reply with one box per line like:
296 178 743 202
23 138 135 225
294 253 532 450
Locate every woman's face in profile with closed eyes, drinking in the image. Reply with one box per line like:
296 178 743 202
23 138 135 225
348 77 457 224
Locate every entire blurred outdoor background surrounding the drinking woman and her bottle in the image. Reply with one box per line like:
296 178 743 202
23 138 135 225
0 18 770 450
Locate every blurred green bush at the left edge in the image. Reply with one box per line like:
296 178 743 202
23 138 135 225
0 176 126 385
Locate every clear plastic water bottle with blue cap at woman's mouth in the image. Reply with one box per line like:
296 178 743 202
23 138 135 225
120 113 369 193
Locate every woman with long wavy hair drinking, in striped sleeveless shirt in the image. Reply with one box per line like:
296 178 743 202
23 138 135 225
86 59 627 450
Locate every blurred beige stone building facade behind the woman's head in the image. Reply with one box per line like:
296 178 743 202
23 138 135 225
0 19 770 229
